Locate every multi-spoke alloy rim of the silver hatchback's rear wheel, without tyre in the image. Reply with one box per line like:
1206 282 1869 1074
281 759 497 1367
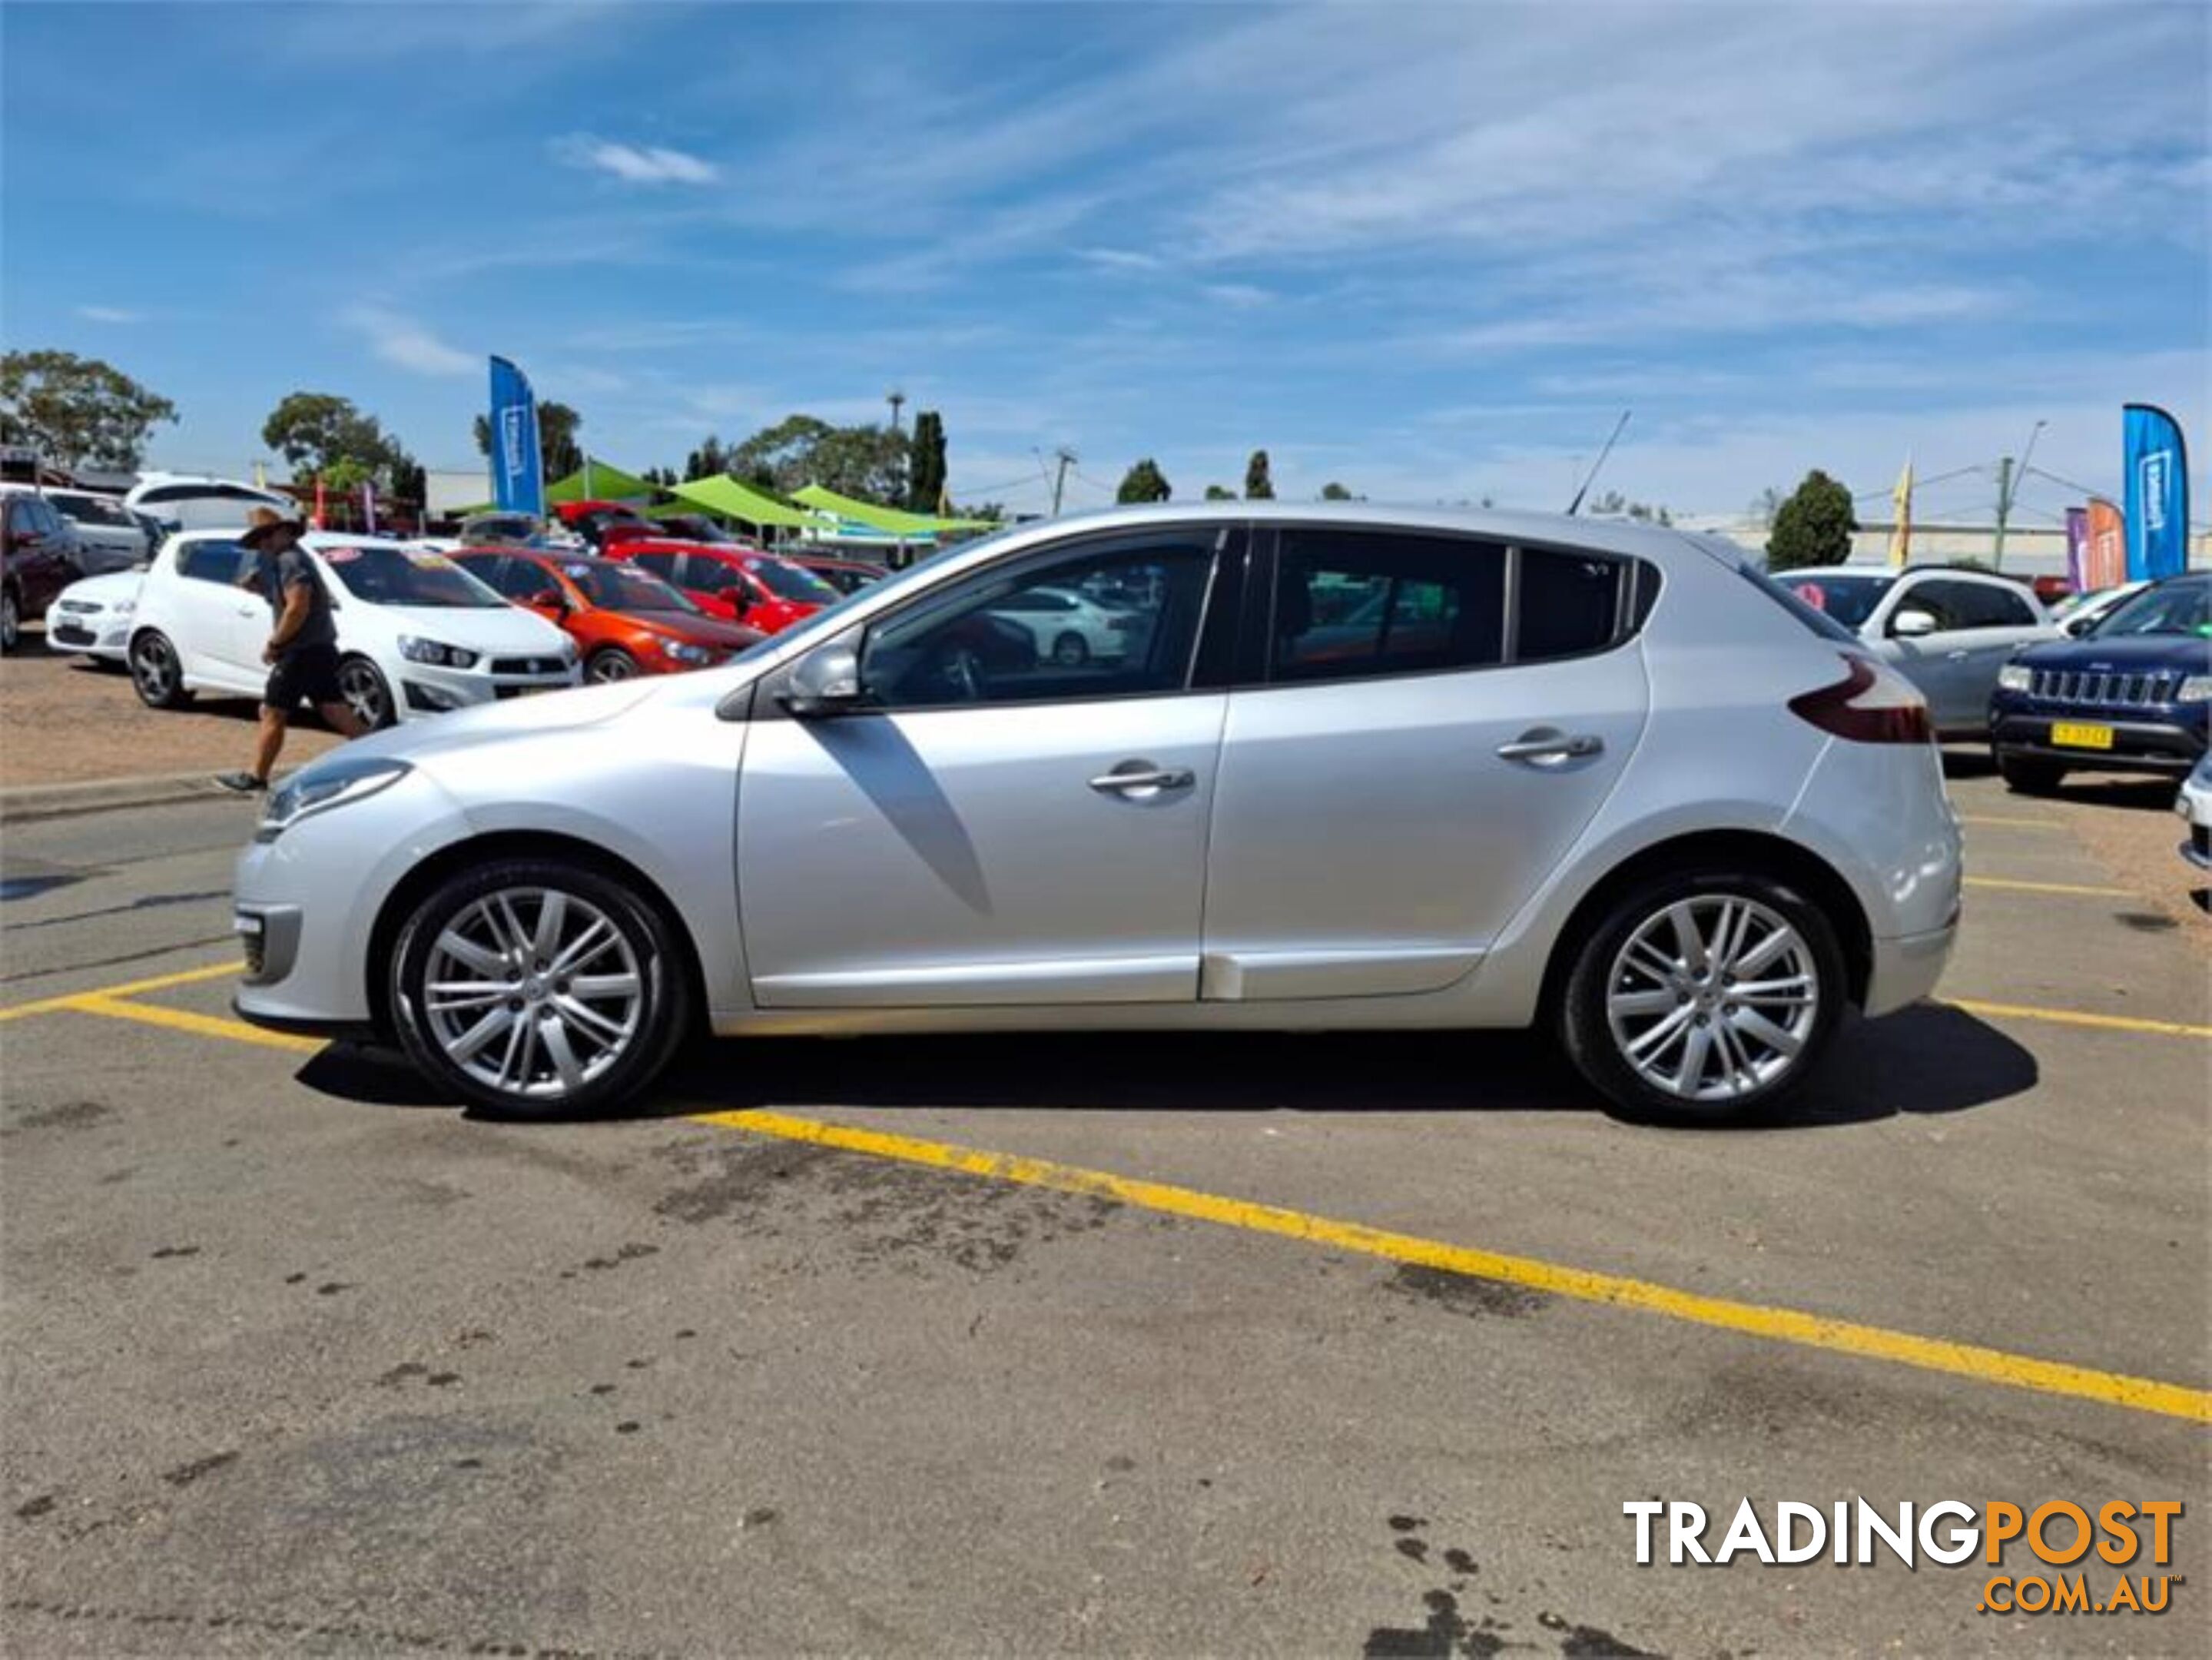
1606 895 1822 1102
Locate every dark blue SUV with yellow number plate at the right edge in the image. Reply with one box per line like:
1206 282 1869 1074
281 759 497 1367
1988 571 2212 792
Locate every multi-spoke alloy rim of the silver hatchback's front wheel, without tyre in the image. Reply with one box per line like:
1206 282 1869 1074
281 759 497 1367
423 888 646 1100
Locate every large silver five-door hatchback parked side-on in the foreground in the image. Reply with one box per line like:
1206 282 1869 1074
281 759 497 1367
237 503 1960 1117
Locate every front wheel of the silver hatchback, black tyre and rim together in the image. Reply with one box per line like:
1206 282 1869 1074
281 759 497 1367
392 858 692 1117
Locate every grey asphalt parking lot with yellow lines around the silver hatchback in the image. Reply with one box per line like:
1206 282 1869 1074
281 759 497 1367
0 765 2212 1655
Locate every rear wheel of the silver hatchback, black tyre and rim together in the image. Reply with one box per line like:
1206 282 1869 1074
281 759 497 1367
1560 865 1849 1122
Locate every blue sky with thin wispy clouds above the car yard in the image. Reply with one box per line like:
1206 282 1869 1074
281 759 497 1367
0 0 2212 518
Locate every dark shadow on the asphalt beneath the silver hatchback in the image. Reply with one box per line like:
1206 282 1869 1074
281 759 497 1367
299 1003 2038 1131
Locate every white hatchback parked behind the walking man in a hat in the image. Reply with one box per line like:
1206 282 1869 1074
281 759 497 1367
131 531 582 726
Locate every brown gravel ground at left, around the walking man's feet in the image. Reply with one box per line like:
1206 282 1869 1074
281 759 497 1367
0 629 338 788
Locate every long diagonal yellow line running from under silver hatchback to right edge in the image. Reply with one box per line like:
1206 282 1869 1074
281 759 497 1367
695 1109 2212 1423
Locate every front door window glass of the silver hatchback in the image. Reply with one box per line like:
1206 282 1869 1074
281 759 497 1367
861 540 1215 709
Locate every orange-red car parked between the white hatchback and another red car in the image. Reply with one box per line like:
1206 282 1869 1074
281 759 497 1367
453 546 763 682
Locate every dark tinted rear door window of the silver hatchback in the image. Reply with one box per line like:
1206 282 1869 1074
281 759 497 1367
1268 529 1507 682
